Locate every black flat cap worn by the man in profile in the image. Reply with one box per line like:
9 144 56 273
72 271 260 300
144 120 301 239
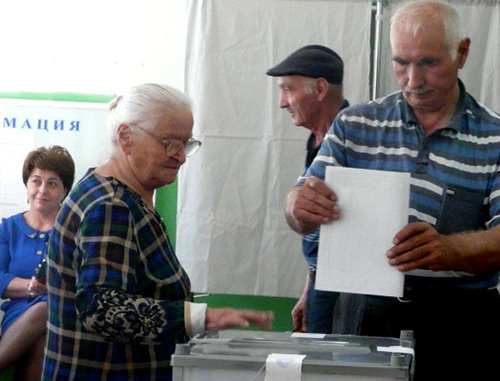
266 45 344 85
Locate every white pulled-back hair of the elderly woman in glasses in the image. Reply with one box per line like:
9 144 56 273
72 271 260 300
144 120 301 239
108 83 191 146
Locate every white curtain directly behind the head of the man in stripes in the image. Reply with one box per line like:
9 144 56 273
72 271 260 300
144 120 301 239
378 0 500 112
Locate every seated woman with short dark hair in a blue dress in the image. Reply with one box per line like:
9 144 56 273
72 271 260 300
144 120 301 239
0 146 75 380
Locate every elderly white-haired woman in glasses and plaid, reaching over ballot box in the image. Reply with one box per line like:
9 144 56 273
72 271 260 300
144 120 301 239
42 84 273 381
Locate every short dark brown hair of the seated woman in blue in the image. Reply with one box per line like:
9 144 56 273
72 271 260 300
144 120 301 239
23 146 75 194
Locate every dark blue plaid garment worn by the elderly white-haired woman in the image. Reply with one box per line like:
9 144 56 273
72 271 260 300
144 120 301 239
42 170 191 380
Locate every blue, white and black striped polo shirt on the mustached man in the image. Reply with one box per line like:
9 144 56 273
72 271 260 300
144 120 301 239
297 80 500 288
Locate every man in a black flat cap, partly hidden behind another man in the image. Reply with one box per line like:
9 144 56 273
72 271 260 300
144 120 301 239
267 45 349 333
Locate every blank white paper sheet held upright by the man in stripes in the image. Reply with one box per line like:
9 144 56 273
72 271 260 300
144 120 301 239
316 166 410 297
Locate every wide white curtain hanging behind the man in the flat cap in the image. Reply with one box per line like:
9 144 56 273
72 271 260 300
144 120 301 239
177 0 371 297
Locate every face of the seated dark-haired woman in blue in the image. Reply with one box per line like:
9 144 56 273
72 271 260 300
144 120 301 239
26 168 66 213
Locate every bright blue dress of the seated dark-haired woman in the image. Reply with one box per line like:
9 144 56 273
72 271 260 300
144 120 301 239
0 213 50 332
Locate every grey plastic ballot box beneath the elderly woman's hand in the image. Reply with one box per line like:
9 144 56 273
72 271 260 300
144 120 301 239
171 330 414 381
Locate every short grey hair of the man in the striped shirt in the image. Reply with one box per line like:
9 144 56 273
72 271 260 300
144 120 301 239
391 0 465 59
